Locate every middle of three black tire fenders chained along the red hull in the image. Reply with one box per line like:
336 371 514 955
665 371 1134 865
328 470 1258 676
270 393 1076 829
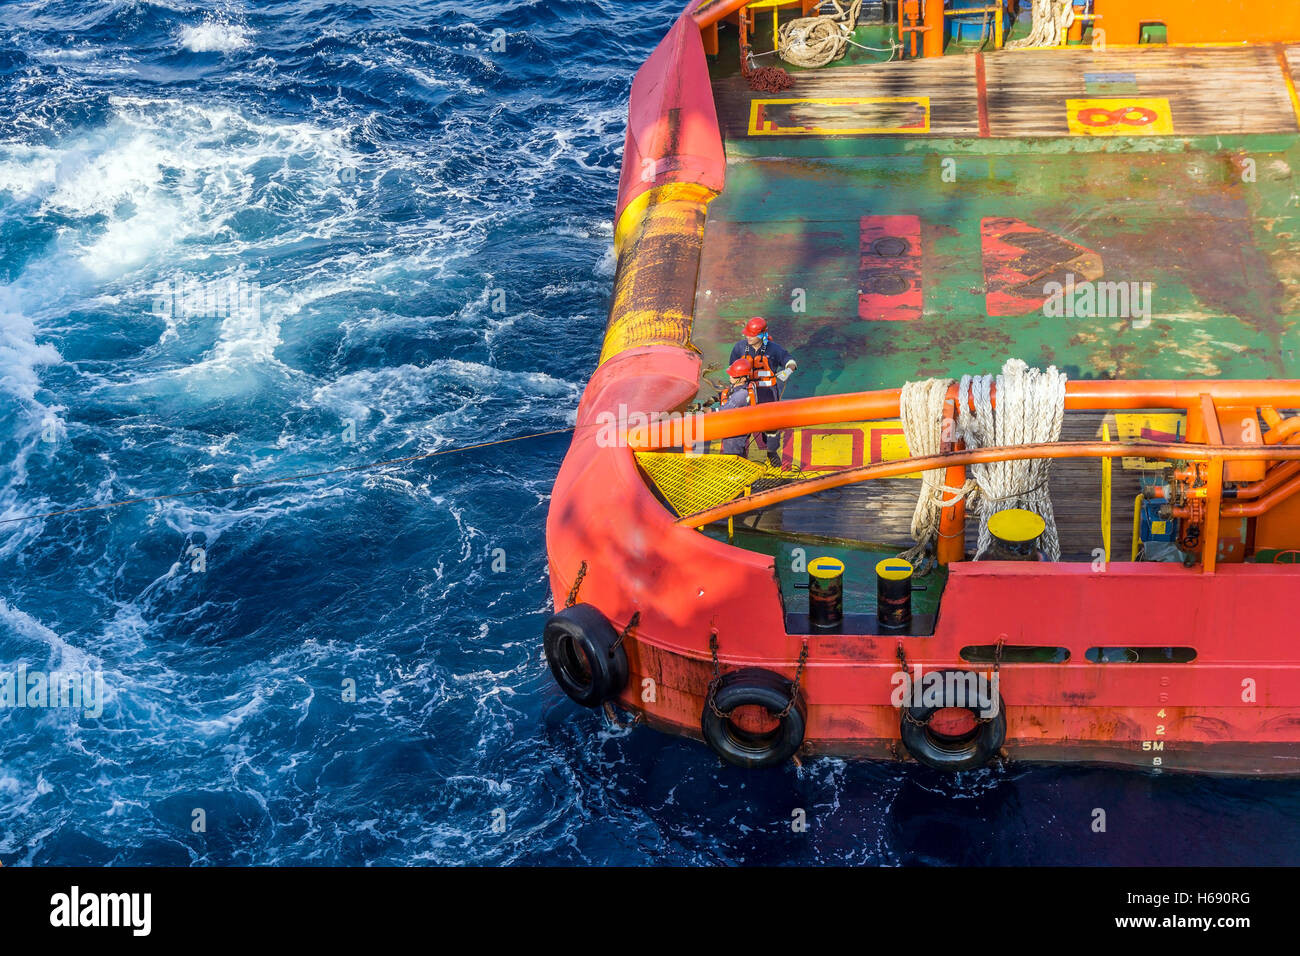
699 667 806 770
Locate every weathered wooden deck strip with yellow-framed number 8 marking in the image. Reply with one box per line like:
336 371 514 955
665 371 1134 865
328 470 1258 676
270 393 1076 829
714 47 1300 145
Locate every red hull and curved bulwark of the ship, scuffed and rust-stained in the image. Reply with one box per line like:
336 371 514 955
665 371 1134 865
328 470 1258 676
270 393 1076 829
547 4 1300 775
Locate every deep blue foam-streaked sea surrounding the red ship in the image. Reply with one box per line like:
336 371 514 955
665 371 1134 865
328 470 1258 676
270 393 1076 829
0 0 1300 866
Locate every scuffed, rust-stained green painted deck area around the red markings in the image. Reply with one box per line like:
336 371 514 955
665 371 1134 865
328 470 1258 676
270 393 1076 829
694 137 1300 397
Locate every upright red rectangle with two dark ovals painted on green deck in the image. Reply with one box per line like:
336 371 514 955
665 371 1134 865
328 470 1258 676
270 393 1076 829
858 216 924 321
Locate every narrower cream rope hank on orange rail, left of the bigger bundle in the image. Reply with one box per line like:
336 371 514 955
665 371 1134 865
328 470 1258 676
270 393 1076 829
898 378 975 574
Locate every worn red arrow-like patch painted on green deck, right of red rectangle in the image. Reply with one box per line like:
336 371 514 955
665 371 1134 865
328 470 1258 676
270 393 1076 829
980 217 1101 316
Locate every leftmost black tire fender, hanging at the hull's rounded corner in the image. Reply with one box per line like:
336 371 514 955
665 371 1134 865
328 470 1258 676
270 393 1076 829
542 604 628 708
